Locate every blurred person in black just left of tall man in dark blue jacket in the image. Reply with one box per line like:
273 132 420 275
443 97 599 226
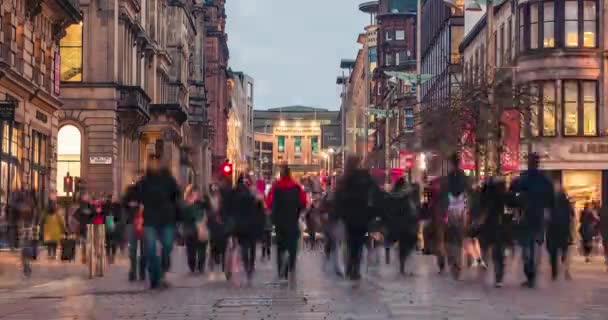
479 177 509 288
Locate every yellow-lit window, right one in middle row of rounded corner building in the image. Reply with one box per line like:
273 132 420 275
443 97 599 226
563 80 598 136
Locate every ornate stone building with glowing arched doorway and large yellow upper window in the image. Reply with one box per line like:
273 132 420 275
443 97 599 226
58 0 206 195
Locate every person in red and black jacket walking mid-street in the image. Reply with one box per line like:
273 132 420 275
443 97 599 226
266 166 308 280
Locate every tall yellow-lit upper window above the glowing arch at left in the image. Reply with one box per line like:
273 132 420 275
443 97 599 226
59 23 82 81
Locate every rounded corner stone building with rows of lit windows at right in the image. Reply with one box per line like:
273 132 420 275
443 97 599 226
460 0 608 208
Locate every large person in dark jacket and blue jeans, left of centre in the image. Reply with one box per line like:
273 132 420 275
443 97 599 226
136 157 179 289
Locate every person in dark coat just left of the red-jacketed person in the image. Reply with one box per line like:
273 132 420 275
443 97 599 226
229 175 265 280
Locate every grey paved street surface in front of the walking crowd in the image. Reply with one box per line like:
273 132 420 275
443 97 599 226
0 247 608 320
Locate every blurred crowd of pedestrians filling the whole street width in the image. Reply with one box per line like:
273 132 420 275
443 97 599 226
4 150 608 289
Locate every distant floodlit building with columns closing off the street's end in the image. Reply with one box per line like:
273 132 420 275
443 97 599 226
253 106 339 176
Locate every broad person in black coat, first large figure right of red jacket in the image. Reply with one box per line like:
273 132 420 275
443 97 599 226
334 156 383 280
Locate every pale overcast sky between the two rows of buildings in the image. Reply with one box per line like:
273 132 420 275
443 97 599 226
226 0 369 109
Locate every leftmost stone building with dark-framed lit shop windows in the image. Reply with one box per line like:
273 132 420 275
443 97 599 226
0 0 82 202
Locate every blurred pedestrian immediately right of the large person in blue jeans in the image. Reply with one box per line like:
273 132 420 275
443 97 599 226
181 186 208 273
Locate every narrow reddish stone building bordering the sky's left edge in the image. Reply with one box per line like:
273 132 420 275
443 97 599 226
205 0 229 172
